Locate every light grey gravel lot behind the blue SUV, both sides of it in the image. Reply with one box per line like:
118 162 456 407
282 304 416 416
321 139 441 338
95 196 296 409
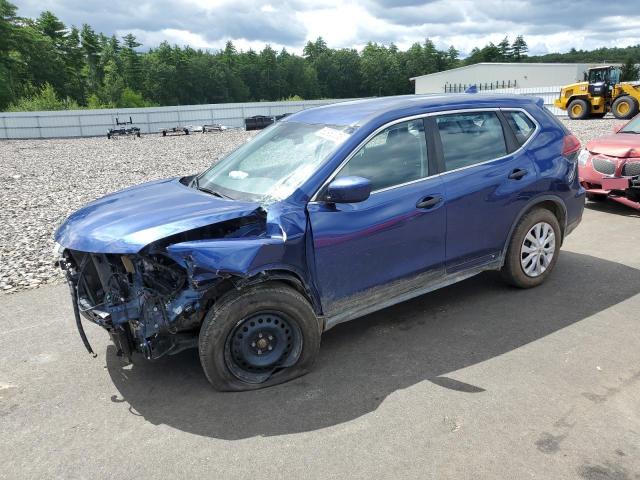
0 118 617 293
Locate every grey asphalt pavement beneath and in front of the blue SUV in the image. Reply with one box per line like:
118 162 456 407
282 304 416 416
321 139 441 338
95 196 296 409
0 198 640 480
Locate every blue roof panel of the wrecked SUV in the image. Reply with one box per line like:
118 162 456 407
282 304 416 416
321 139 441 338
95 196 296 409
282 93 538 126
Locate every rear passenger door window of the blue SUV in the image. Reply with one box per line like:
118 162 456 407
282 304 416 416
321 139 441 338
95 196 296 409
436 112 507 171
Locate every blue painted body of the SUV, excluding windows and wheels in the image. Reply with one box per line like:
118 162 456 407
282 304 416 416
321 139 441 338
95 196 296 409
55 94 584 338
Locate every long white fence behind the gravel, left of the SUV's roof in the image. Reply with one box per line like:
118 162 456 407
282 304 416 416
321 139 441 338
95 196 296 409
0 99 356 139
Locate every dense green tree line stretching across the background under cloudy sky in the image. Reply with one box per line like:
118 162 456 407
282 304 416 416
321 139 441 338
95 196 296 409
0 0 640 111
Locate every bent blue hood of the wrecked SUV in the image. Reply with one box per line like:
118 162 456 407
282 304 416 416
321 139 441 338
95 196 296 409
55 179 260 253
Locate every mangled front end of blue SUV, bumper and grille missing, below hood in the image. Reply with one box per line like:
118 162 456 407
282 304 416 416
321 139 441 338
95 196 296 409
60 250 204 359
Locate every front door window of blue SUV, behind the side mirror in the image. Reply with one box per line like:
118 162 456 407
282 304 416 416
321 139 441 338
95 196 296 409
336 119 429 191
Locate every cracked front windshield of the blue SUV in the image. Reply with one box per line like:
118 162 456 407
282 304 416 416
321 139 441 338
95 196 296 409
194 122 354 203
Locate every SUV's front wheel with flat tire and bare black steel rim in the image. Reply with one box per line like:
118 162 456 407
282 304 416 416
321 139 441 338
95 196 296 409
198 282 321 392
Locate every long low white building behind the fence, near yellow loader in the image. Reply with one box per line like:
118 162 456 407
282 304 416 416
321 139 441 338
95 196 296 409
411 63 596 93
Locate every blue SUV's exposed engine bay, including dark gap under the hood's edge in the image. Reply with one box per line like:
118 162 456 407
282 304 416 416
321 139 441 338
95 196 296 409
58 209 276 360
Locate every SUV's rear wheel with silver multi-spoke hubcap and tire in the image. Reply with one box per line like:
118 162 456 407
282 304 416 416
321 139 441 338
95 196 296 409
502 208 561 288
